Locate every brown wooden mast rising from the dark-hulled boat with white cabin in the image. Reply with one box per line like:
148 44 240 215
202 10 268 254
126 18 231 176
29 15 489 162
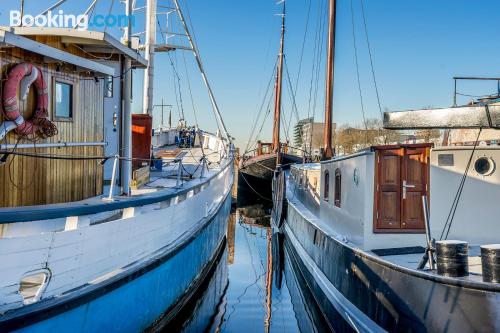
323 0 337 159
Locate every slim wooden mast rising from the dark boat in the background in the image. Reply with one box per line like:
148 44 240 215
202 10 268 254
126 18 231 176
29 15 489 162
273 1 286 165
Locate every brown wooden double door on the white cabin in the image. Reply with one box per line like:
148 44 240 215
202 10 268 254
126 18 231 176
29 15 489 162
374 144 431 232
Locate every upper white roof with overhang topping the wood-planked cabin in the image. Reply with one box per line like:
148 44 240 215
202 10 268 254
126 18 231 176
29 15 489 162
1 27 148 68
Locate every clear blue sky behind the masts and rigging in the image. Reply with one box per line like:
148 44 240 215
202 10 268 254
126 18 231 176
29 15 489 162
0 0 500 146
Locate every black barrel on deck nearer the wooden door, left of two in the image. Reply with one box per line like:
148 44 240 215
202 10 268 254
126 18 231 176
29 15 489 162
436 240 469 277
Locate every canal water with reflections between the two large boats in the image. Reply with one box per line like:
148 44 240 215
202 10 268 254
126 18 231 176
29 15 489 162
165 206 330 333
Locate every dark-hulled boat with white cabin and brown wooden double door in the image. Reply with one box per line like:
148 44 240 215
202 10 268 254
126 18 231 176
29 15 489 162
272 0 500 332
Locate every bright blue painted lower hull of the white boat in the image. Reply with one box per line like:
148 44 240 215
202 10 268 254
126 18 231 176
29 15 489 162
14 196 231 332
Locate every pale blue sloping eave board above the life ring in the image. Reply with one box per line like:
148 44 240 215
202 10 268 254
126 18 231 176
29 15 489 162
0 29 115 75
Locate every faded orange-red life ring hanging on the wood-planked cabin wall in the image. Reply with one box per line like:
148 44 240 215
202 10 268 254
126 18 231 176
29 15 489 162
2 63 57 137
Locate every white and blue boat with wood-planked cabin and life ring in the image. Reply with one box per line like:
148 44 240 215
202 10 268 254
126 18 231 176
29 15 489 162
0 0 233 332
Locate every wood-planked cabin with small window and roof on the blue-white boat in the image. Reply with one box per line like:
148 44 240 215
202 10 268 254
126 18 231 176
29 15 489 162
0 27 146 207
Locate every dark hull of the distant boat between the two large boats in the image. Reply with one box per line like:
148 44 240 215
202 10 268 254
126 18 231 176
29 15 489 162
238 154 302 206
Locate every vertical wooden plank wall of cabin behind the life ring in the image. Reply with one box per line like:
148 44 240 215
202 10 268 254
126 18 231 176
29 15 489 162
0 46 104 207
